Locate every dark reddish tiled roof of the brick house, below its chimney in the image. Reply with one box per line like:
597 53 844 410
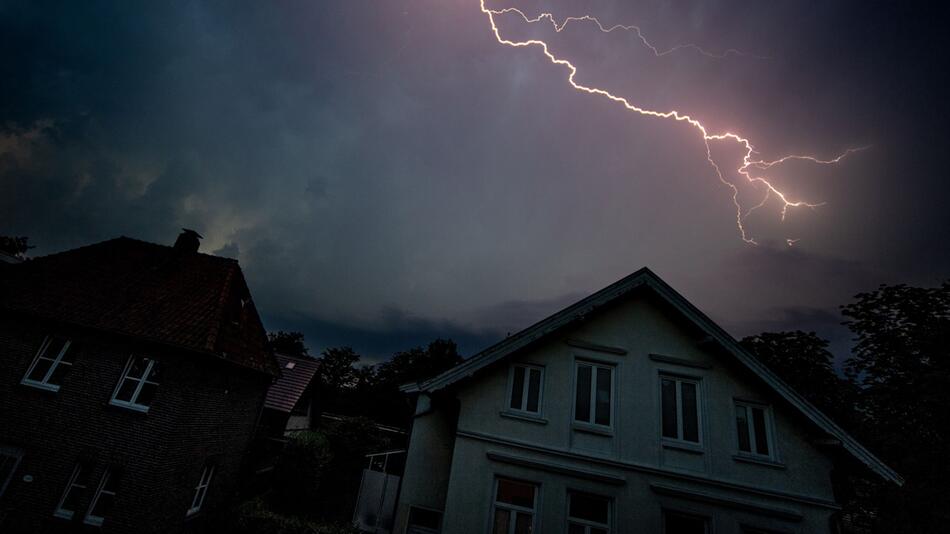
0 237 277 375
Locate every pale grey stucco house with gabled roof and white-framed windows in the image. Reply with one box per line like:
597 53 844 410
393 269 903 534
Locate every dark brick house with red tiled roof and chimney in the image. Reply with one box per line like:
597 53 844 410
0 231 279 533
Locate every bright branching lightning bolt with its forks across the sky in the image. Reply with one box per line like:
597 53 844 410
479 0 868 246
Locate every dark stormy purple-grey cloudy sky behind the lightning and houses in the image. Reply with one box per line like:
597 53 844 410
0 0 950 366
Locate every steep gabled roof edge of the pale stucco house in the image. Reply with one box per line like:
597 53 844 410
402 267 904 485
